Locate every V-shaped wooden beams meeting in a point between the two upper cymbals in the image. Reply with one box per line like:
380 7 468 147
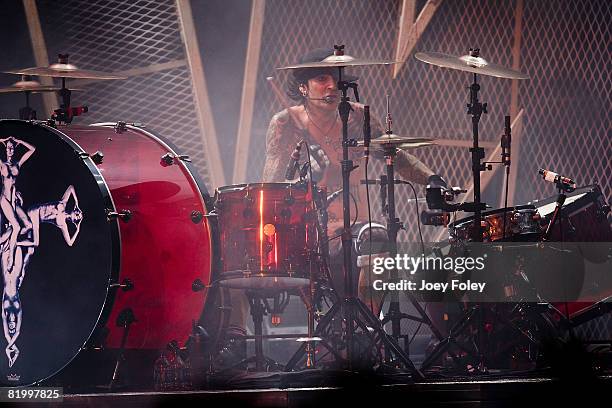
393 0 443 79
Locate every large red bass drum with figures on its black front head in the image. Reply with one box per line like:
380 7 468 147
0 120 218 386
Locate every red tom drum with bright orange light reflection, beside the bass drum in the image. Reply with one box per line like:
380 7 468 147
215 183 317 290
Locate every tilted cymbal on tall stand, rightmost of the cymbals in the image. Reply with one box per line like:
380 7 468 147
414 52 529 79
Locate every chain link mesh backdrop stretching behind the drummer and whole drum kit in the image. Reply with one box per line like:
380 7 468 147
31 0 612 348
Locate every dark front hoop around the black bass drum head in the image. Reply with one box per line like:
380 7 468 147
0 119 121 386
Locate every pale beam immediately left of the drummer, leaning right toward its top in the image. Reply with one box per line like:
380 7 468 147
232 0 266 184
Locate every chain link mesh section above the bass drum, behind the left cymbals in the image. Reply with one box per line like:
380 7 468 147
37 0 214 193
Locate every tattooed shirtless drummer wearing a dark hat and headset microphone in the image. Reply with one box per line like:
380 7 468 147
219 49 444 366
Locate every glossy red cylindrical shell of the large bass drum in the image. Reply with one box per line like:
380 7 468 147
65 124 213 349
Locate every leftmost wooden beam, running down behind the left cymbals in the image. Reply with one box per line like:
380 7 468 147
23 0 59 113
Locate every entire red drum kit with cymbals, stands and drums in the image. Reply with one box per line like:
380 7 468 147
0 46 612 387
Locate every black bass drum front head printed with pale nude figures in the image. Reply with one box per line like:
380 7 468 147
0 120 120 386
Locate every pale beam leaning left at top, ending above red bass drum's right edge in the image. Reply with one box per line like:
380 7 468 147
176 0 225 188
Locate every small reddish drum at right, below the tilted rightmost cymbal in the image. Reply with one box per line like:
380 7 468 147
448 205 542 242
